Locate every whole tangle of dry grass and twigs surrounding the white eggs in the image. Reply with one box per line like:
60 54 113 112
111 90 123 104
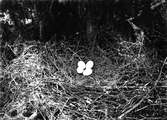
0 0 167 120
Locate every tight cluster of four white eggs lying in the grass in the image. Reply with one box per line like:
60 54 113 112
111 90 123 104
77 60 94 76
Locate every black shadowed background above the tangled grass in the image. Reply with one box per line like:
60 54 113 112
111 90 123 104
1 0 167 57
